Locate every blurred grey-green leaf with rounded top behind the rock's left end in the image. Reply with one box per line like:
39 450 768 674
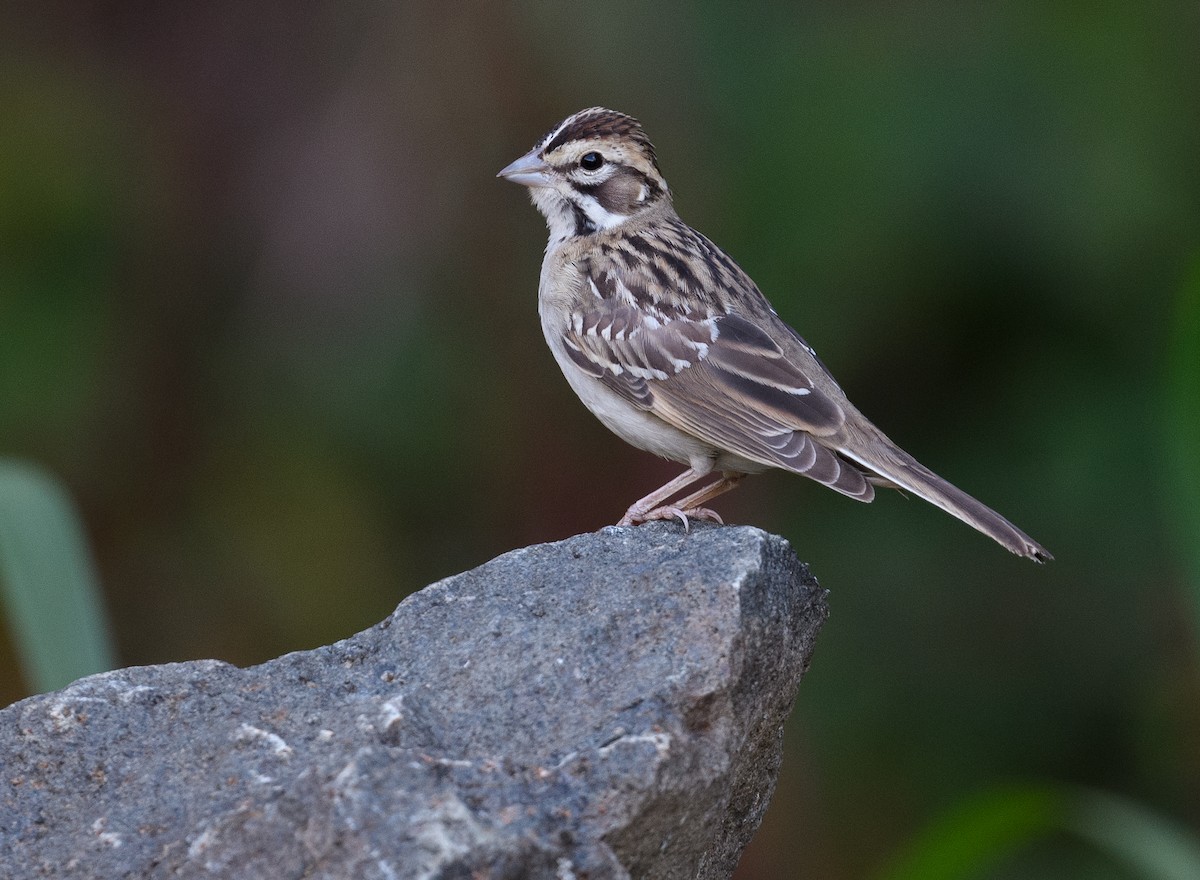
0 461 116 692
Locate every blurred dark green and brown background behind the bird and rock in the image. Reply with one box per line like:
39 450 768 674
0 0 1200 880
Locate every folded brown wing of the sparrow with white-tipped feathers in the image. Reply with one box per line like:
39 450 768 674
563 282 874 501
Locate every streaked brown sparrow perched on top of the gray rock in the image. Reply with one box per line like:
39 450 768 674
497 107 1052 562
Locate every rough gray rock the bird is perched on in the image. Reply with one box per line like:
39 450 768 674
0 523 827 880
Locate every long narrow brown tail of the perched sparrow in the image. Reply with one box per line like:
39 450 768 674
838 432 1054 562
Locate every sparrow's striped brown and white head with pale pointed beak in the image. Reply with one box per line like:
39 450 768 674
497 107 671 240
